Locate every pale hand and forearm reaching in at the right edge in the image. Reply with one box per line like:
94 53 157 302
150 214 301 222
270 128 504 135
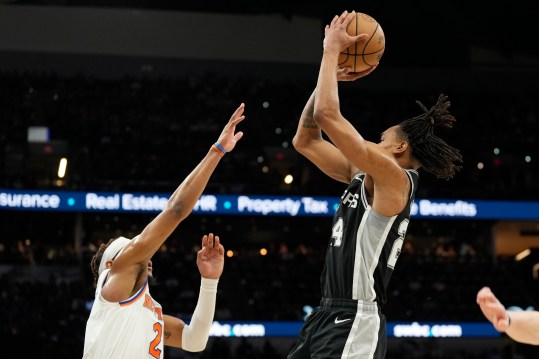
477 287 539 345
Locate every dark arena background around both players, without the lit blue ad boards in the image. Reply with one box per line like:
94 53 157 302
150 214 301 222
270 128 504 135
0 1 539 358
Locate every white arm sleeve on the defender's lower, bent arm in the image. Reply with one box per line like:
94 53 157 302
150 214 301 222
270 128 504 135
182 277 219 352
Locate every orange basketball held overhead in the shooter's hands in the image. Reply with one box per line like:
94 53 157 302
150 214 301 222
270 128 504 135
339 12 386 72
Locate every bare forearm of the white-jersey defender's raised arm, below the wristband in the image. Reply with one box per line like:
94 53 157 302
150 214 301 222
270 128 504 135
167 148 221 219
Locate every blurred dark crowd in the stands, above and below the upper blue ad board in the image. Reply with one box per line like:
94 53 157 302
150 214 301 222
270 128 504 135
0 72 539 359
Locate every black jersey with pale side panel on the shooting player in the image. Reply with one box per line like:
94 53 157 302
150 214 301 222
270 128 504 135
321 170 419 305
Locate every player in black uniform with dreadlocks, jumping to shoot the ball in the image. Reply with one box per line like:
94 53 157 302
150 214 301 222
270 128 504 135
288 11 462 359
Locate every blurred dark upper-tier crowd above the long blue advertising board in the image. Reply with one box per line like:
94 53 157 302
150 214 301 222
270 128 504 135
0 72 539 200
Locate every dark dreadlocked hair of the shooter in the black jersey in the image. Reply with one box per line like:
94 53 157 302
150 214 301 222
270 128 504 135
399 94 462 180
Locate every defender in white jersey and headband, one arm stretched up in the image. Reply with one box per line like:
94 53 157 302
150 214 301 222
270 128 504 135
83 104 245 359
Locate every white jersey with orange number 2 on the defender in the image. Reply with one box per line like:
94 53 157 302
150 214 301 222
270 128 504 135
83 269 164 359
